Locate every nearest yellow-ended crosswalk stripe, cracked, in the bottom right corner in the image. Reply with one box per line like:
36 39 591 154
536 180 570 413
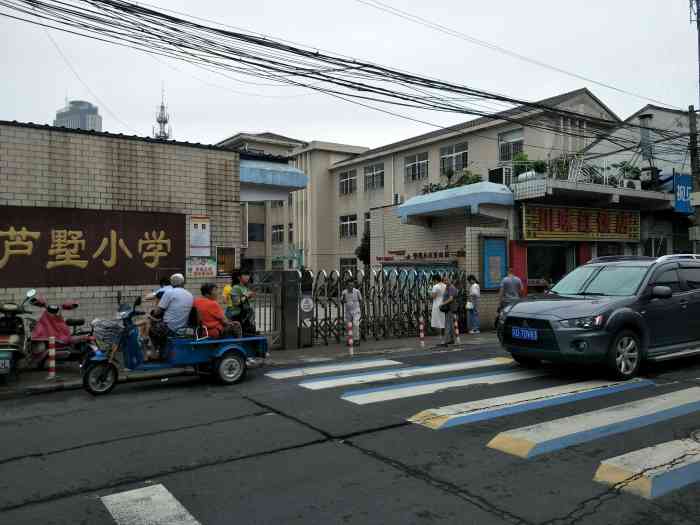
593 439 700 499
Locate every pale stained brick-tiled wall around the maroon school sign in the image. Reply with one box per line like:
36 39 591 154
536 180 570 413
0 123 241 320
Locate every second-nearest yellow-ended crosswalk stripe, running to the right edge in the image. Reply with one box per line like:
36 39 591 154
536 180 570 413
488 387 700 458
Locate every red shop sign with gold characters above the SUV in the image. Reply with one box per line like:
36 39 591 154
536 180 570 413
523 204 640 242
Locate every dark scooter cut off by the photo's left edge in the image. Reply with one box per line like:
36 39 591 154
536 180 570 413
0 290 36 382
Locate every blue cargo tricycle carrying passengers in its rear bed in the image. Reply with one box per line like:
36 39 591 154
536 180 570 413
81 298 268 396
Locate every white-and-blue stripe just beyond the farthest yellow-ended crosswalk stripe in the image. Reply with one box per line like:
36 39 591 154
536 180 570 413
341 370 546 405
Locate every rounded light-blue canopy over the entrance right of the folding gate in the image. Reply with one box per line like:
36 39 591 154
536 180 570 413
394 182 513 223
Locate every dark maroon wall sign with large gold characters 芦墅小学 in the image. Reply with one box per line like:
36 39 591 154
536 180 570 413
0 206 186 288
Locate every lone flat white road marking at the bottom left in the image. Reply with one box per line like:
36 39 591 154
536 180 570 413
101 485 200 525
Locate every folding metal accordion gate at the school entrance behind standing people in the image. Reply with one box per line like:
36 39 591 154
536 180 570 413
301 270 468 344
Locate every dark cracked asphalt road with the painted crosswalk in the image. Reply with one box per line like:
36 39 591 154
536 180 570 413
0 348 700 525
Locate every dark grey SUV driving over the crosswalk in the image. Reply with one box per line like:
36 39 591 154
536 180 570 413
498 255 700 379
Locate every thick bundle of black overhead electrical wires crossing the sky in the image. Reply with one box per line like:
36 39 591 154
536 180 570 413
0 0 688 162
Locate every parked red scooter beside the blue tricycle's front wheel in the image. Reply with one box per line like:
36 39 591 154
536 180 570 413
30 296 96 368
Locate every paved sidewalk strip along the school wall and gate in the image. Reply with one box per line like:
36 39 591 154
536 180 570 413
0 332 498 401
